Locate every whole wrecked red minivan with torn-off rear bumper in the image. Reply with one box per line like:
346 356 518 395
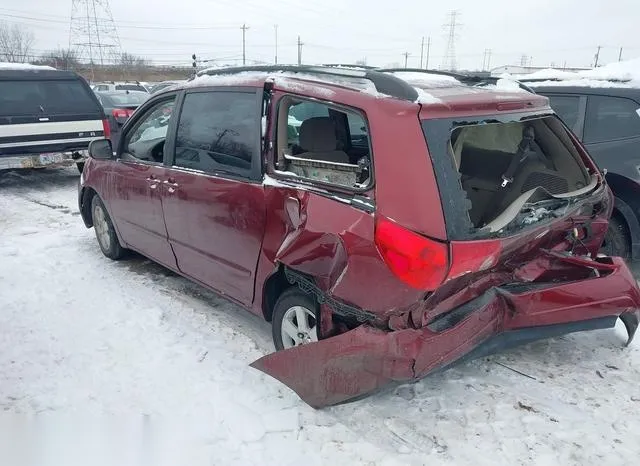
79 67 640 407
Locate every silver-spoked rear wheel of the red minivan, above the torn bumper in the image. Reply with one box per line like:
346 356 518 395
271 288 320 351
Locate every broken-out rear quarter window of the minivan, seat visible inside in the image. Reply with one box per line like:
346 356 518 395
275 97 372 189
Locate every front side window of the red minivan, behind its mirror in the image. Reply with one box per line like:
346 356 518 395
124 96 176 163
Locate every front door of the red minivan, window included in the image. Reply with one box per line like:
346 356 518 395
107 94 177 269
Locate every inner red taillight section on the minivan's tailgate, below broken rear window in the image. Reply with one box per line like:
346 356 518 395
447 240 502 280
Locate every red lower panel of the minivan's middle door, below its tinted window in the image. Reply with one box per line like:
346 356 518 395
162 168 266 306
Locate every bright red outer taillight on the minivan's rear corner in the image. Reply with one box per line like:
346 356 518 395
375 218 449 291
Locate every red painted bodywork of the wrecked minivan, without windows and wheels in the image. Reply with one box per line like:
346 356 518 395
81 72 640 407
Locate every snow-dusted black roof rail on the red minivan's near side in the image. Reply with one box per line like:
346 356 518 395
191 65 418 102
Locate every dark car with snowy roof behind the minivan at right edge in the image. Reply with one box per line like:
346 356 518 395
528 81 640 260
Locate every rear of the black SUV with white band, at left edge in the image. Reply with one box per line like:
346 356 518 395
0 72 104 156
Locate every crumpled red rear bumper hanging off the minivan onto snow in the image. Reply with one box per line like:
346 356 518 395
252 258 640 408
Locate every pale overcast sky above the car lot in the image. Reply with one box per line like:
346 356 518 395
5 0 640 69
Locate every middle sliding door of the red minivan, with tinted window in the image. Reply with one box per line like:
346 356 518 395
163 88 265 304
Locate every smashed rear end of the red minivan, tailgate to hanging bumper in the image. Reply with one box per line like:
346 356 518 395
253 95 640 407
